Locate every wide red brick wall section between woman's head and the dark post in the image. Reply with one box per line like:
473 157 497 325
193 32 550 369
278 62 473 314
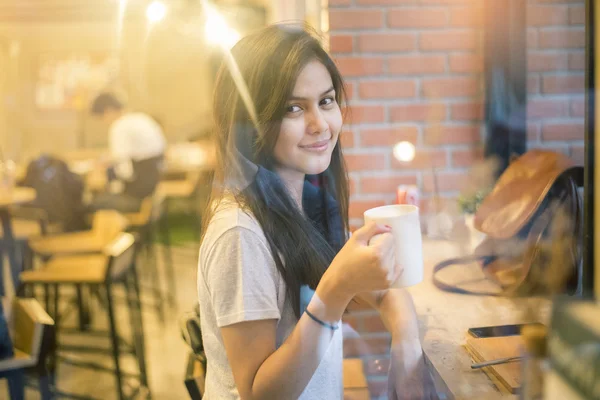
329 0 484 231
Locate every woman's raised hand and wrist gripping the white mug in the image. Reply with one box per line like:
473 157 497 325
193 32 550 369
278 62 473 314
317 222 402 320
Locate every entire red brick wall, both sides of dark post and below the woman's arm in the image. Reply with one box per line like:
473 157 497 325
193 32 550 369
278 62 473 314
329 0 585 398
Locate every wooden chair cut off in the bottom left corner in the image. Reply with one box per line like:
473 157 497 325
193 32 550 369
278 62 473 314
0 298 55 400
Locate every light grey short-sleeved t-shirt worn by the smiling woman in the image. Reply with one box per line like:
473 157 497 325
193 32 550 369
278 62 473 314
198 203 343 400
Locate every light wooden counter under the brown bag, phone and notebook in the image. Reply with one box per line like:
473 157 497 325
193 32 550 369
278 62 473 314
408 239 550 400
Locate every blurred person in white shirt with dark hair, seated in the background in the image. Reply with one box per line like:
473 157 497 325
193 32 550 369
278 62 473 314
91 93 166 212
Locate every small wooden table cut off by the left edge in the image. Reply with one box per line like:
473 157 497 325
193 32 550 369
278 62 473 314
0 187 36 296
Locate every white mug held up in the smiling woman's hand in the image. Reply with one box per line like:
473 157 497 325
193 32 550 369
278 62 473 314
364 204 423 288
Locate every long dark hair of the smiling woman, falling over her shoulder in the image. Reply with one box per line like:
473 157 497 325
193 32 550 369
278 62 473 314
202 25 348 317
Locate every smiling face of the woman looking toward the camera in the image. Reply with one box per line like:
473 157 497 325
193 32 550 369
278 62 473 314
273 61 342 179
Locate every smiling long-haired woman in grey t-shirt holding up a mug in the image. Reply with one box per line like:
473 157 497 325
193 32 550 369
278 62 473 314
198 25 434 400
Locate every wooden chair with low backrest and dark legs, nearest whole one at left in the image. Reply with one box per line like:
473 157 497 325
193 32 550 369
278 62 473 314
21 232 149 400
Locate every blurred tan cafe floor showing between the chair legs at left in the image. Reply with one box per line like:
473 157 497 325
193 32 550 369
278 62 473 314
0 244 198 400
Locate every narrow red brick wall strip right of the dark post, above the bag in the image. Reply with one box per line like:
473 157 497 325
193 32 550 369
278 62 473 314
527 0 585 165
